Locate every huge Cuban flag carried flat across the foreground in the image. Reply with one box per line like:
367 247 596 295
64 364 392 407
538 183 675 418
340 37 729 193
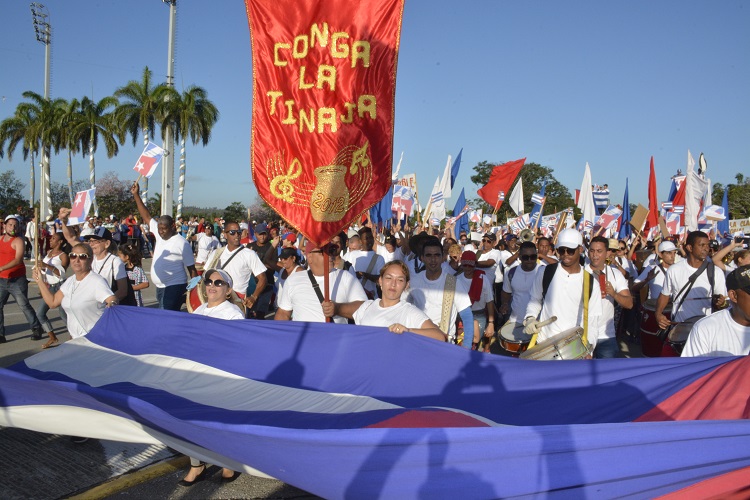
0 306 750 499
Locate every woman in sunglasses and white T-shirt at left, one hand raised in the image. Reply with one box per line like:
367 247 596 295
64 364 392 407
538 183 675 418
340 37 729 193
33 243 117 339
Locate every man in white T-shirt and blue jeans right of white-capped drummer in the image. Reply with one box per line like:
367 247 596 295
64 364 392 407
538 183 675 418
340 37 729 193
585 236 633 359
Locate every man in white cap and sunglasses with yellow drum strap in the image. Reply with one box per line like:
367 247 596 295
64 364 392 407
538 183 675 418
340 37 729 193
524 229 602 352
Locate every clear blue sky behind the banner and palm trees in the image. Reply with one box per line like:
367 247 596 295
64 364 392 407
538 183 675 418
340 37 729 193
0 0 750 212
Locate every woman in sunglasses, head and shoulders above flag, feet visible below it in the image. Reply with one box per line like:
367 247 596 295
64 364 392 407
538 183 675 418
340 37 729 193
179 269 245 486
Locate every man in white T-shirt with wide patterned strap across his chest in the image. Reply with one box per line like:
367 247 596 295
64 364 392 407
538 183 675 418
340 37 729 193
406 236 474 349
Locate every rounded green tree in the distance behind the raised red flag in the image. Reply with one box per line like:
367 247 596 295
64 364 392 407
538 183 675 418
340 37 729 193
470 161 575 221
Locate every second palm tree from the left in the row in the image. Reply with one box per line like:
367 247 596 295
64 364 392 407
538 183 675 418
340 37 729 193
17 90 66 219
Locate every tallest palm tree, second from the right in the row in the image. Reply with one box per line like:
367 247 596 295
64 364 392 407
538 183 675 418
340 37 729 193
115 66 174 200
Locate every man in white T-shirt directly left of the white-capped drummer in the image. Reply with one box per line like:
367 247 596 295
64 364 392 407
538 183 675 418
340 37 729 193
500 241 540 323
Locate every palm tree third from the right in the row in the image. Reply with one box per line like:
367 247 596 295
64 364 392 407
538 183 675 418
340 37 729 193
71 96 121 216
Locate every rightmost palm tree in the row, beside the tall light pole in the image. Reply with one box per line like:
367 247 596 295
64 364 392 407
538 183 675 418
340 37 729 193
164 85 219 217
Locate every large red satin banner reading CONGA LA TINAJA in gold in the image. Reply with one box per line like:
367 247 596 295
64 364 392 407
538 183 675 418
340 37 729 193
246 0 404 244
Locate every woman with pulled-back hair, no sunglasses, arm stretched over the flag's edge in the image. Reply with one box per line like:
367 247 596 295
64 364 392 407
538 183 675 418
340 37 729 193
322 260 446 342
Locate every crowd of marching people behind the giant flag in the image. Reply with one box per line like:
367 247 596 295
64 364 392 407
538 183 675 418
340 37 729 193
0 188 750 485
